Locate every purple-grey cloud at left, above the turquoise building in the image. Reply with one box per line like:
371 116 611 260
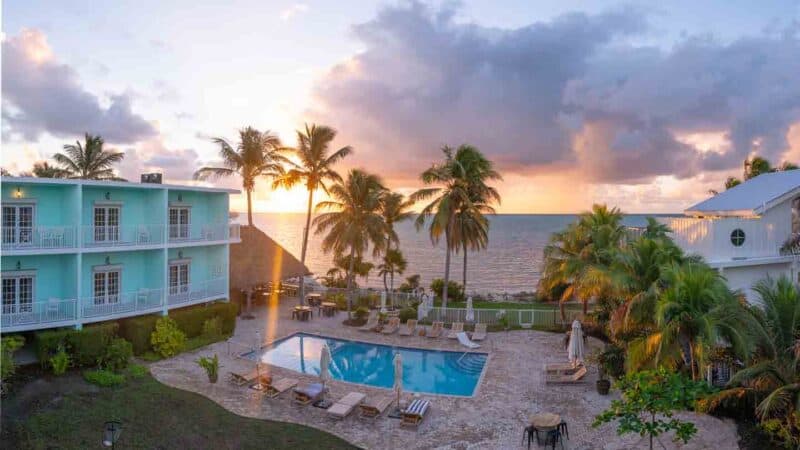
2 29 157 143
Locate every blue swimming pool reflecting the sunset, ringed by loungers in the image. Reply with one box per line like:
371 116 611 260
242 333 488 397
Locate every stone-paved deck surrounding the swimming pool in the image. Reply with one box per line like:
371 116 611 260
150 300 738 450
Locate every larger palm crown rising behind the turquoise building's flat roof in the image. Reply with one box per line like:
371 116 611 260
53 133 125 181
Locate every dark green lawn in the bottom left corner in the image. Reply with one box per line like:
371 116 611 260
3 374 355 449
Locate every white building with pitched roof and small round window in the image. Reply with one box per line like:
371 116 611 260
662 170 800 300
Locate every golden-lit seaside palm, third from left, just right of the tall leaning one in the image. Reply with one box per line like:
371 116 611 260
314 169 386 316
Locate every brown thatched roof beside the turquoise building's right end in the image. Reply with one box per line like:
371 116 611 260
230 225 311 290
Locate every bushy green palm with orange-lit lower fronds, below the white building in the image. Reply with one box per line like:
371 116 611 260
628 261 750 380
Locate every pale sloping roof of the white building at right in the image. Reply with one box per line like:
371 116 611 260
684 170 800 217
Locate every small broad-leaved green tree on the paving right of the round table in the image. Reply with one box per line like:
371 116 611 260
592 369 708 450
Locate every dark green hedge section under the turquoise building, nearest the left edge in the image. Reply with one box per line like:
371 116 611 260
34 322 119 366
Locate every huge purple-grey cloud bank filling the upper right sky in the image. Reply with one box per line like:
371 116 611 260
309 3 800 184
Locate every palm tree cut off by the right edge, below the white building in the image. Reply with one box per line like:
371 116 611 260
707 277 800 420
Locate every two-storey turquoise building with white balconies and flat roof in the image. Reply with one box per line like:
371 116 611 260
0 177 240 333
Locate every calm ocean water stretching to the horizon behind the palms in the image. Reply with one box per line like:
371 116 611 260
247 213 672 294
